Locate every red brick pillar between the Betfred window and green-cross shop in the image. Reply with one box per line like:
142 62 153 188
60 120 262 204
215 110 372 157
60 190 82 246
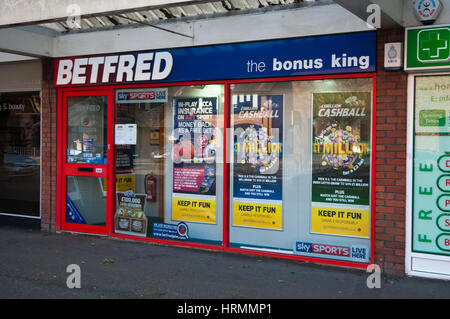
375 29 407 275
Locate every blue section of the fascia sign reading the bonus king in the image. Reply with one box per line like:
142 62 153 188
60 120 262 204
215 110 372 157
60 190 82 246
165 32 376 81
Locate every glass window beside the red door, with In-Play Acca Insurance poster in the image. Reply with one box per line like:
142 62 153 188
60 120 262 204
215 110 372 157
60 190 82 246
114 85 224 245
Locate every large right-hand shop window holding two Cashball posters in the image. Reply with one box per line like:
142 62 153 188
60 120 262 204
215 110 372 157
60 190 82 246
229 78 373 263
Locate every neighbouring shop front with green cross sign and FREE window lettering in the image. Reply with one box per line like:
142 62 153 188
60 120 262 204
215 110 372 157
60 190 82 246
405 26 450 279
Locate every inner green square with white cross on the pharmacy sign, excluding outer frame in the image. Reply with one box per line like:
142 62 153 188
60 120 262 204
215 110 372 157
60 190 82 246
417 28 450 62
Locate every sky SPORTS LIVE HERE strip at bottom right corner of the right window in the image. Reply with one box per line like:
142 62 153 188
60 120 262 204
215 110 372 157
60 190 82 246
294 241 370 262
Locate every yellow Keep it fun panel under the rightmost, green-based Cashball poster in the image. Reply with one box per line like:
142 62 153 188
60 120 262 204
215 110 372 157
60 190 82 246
311 206 370 238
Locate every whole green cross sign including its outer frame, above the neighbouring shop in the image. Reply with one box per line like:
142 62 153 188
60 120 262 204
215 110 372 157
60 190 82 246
405 26 450 71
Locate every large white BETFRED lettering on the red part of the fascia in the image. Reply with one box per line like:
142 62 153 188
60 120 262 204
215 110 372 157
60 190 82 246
56 52 173 85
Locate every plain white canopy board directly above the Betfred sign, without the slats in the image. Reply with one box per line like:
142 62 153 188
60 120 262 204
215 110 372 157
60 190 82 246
52 3 373 57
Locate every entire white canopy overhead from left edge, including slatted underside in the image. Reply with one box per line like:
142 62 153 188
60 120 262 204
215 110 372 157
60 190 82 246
0 0 373 57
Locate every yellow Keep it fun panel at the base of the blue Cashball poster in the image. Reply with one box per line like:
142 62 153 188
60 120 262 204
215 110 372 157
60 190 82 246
233 201 283 230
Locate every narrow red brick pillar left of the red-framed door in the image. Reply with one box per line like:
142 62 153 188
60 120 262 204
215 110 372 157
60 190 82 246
41 59 58 232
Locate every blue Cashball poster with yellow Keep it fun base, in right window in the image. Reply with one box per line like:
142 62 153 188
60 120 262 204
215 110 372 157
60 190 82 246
232 94 283 230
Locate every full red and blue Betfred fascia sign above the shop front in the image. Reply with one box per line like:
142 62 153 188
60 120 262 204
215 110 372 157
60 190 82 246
55 31 376 87
